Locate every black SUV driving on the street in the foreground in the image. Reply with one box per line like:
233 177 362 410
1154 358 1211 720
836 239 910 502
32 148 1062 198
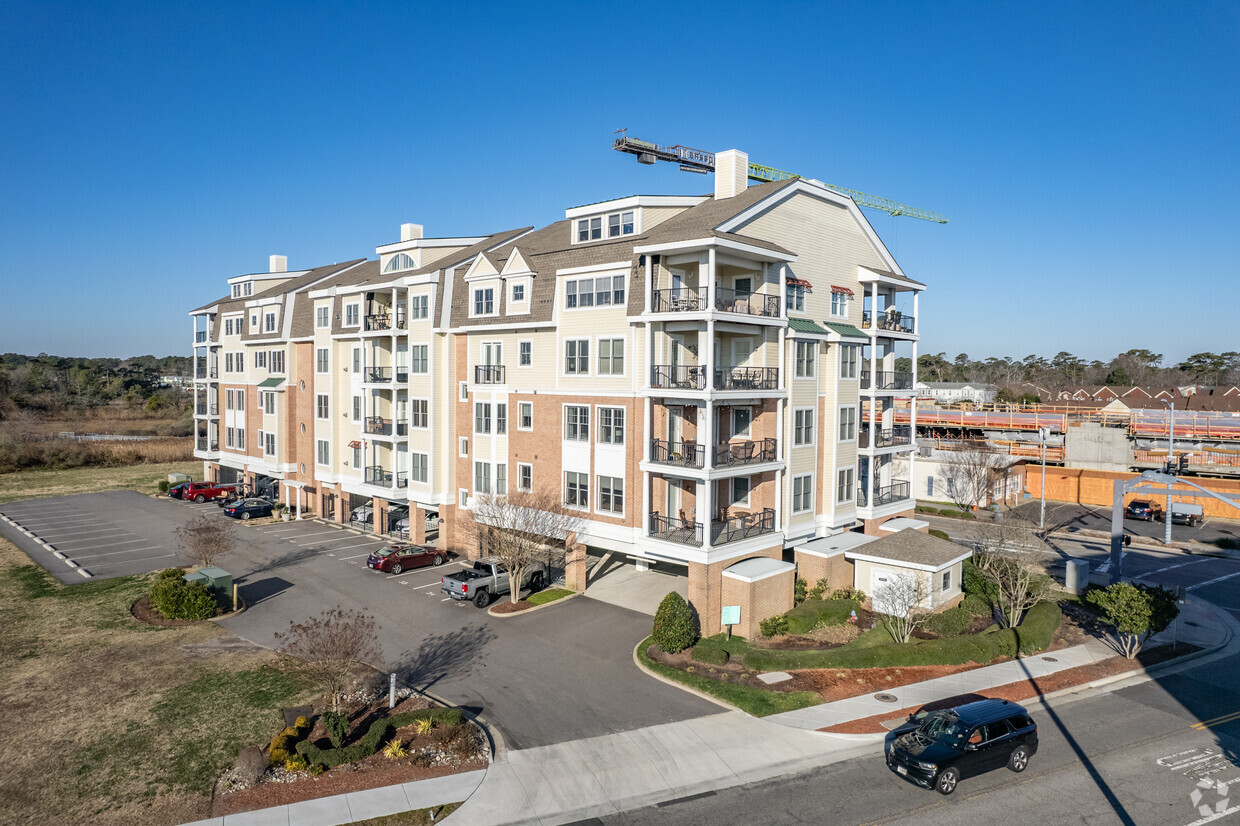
887 699 1038 795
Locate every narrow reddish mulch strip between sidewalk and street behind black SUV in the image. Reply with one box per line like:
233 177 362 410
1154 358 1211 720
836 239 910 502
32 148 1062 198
818 642 1200 734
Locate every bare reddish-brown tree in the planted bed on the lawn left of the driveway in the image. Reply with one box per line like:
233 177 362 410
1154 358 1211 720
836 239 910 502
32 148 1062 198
275 605 381 712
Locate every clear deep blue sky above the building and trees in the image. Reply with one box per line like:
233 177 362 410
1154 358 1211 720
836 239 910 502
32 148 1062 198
0 0 1240 363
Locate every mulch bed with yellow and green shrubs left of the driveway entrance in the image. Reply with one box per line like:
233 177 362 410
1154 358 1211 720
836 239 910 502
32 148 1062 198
211 697 489 817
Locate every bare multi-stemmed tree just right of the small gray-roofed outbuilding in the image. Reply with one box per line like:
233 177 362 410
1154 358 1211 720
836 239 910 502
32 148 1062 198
968 511 1053 628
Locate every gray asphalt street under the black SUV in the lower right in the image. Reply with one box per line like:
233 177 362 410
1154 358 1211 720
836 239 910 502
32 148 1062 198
598 644 1240 826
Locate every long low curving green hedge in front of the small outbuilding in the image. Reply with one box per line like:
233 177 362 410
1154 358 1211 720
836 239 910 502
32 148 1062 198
745 603 1063 671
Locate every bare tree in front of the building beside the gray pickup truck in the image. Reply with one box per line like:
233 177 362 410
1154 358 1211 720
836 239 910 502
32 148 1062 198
466 490 585 603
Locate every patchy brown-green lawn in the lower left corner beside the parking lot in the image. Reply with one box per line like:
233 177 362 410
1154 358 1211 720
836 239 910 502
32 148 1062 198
0 538 311 826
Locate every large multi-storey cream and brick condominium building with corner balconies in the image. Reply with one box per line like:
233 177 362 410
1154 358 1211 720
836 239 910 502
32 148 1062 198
191 150 924 633
